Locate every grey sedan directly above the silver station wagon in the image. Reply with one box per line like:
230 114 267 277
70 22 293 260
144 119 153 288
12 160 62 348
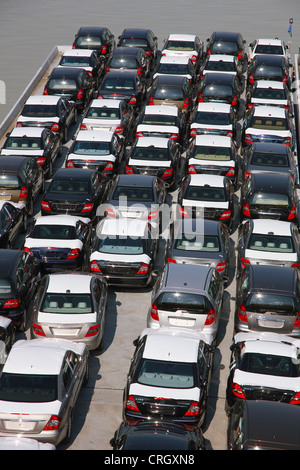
166 219 230 282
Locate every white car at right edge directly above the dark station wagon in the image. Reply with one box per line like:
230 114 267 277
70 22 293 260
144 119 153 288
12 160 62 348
237 219 300 276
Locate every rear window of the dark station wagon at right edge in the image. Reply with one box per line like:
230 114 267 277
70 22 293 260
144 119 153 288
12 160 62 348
244 293 299 315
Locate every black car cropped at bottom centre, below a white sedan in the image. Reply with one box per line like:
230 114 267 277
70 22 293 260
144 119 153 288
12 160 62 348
110 419 205 451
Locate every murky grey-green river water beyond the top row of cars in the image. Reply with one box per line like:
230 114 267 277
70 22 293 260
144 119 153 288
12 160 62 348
0 0 300 123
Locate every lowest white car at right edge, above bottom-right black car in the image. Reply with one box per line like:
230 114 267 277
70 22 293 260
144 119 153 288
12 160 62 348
226 332 300 407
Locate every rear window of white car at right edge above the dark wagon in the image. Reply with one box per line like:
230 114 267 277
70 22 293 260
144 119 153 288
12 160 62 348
247 233 295 253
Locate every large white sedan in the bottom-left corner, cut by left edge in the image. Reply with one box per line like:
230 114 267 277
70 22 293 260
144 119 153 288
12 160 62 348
0 338 89 446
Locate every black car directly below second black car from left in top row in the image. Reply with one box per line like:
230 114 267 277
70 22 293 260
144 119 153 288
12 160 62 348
106 46 150 80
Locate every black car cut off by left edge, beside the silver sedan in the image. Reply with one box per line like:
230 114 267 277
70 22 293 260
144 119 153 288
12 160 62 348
0 248 41 331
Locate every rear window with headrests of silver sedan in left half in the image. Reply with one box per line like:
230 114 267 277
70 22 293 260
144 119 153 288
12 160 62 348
40 292 94 315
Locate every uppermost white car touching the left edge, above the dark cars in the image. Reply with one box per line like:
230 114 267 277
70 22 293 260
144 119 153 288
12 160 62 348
0 127 62 178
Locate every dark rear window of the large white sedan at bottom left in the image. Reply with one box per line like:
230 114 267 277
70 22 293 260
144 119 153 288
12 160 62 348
0 372 58 403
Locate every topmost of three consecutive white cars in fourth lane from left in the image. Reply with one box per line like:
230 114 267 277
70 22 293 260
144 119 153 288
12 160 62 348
190 102 236 139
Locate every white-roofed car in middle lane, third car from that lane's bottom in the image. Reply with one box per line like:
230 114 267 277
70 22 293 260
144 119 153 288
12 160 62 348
125 137 181 189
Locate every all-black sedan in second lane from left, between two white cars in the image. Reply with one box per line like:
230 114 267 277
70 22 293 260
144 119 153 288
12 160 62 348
41 168 107 221
